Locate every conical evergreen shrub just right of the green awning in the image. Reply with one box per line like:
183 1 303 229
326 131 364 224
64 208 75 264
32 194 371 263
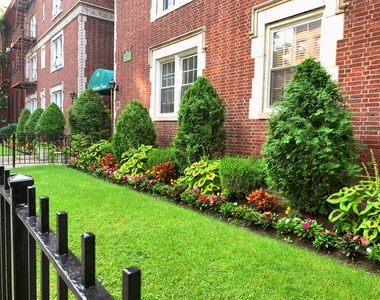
112 100 157 161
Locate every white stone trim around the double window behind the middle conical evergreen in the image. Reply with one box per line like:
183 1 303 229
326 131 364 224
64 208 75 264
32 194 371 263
149 28 206 121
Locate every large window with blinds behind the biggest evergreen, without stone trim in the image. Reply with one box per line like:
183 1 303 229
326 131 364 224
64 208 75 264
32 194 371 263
270 19 321 104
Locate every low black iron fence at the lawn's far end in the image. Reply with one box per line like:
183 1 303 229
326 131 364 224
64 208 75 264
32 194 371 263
0 135 73 167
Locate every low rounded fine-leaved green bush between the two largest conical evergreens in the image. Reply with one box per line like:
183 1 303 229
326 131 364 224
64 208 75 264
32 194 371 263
219 156 267 198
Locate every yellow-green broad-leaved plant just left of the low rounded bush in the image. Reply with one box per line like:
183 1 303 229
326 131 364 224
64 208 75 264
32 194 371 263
184 159 221 195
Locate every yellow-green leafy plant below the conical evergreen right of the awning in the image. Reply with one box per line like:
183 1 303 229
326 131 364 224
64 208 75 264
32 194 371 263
115 145 152 180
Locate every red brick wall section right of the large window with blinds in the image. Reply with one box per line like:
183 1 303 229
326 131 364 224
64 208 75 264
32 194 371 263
337 0 380 161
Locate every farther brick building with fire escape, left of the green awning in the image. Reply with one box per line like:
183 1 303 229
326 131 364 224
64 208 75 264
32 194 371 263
0 0 114 123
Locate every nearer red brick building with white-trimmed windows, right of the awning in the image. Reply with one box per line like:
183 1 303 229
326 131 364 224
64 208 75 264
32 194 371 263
115 0 380 160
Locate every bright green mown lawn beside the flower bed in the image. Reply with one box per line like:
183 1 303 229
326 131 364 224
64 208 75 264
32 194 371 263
11 165 380 300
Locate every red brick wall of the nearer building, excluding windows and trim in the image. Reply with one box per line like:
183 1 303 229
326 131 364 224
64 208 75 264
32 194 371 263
115 0 380 160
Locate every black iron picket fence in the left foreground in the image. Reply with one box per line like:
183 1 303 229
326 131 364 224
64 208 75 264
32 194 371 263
0 166 141 300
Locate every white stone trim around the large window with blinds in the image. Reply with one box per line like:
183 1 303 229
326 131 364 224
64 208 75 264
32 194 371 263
249 0 344 119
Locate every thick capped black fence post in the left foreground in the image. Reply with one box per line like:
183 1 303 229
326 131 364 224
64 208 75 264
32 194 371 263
8 175 34 299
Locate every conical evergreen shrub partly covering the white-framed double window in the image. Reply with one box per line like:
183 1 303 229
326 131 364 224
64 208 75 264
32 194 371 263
172 76 226 171
